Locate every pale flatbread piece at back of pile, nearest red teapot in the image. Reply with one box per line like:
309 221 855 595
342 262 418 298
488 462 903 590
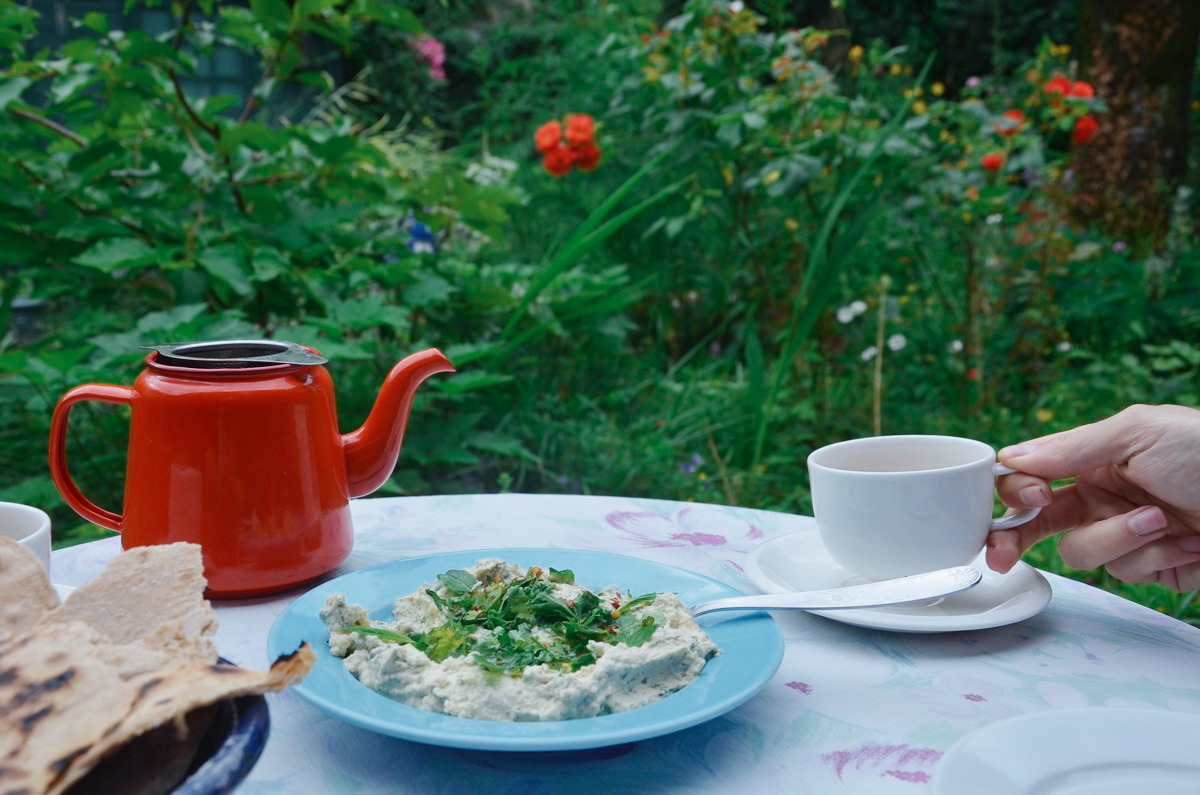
37 543 217 664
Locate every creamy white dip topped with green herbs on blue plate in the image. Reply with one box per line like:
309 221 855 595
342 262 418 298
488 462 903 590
320 558 719 721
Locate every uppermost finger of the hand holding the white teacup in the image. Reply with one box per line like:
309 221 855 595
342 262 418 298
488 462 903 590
996 410 1145 480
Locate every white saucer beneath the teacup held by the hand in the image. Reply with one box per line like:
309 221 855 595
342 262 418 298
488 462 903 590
745 530 1050 632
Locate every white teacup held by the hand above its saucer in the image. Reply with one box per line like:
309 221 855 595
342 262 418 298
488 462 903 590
809 435 1040 580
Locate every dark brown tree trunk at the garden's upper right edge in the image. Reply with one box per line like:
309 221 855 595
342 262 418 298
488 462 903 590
1075 0 1200 247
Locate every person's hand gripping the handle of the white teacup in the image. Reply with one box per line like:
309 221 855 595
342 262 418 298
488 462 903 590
986 406 1200 591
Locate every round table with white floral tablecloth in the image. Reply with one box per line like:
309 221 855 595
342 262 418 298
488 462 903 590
52 494 1200 795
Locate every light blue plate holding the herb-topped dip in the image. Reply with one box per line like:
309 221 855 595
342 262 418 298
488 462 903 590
266 549 784 751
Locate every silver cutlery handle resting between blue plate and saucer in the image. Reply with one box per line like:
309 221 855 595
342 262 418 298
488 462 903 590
691 566 983 616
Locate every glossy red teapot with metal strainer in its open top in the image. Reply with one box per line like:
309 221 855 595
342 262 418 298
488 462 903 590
50 340 454 598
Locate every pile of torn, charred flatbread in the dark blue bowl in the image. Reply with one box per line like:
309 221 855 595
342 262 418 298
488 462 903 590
0 543 316 795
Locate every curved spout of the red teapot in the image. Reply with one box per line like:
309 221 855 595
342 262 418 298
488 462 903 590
342 348 454 497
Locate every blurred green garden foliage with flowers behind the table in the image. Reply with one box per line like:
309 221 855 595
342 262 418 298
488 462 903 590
0 0 1200 623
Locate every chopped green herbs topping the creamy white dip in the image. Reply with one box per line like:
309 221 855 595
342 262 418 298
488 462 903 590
343 567 658 675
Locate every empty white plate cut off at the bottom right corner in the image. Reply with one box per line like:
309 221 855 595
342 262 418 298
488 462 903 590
931 707 1200 795
